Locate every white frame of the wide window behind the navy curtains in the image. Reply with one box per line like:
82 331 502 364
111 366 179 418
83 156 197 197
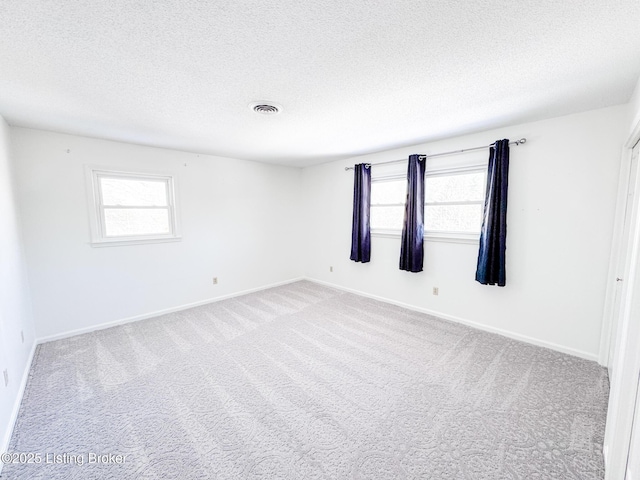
371 161 488 243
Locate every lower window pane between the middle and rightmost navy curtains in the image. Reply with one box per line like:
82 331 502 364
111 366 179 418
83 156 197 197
424 204 483 233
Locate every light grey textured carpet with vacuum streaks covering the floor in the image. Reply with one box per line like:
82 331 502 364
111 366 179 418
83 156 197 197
2 282 608 480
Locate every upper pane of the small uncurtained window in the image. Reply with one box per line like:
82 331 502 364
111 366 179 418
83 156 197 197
100 177 167 207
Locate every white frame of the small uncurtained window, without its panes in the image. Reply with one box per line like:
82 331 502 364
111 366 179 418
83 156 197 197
85 165 182 247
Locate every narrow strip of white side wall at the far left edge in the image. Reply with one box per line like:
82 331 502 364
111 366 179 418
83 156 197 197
0 117 34 462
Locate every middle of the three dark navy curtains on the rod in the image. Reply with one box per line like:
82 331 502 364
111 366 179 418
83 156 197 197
400 155 427 272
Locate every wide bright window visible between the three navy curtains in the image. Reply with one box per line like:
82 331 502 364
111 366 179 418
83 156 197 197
371 165 486 240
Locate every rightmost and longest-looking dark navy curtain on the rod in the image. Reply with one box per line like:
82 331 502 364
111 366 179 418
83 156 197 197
476 139 509 287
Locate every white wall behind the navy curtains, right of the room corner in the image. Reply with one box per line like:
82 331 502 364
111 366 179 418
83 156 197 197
303 106 627 360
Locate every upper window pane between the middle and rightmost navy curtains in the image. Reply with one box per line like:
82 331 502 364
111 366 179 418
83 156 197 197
424 172 485 203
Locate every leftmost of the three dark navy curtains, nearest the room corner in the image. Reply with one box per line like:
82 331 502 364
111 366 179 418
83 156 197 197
351 163 371 263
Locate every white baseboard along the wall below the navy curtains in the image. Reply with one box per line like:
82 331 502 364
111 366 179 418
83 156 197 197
305 277 598 362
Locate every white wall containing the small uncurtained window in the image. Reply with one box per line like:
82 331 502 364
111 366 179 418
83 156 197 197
12 128 302 338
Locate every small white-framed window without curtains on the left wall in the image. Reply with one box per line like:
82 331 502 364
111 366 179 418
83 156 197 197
88 168 180 245
